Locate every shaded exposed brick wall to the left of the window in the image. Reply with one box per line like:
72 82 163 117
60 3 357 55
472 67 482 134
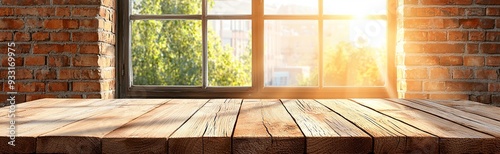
0 0 117 102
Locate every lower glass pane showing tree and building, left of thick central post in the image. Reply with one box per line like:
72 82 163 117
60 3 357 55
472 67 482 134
207 20 252 86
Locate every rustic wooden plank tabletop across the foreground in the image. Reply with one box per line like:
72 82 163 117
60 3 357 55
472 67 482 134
0 99 500 154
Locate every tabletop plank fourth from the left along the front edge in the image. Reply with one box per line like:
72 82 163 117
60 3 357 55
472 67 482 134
168 99 242 153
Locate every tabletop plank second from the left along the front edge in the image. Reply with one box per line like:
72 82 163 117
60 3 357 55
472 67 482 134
36 99 168 153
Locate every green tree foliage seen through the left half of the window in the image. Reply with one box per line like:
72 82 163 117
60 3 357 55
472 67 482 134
131 0 251 86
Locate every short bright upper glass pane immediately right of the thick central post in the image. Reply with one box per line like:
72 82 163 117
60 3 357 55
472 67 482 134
264 0 318 15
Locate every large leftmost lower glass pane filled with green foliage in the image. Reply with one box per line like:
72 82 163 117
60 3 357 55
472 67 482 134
131 20 202 86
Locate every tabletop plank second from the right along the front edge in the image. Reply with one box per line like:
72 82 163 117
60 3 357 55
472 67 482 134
318 99 439 153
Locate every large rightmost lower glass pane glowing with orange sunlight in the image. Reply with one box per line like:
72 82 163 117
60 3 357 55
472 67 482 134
323 20 387 86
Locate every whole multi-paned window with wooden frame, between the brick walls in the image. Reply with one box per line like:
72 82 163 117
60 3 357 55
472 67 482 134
119 0 396 98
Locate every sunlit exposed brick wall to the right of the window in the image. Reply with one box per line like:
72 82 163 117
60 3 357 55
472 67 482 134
397 0 500 105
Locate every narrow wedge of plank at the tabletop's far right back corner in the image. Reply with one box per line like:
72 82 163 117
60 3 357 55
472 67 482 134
432 101 500 121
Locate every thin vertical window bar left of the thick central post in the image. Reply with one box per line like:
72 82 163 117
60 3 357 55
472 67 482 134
201 0 208 89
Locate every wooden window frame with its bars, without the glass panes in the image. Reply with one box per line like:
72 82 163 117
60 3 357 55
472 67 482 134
116 0 397 98
